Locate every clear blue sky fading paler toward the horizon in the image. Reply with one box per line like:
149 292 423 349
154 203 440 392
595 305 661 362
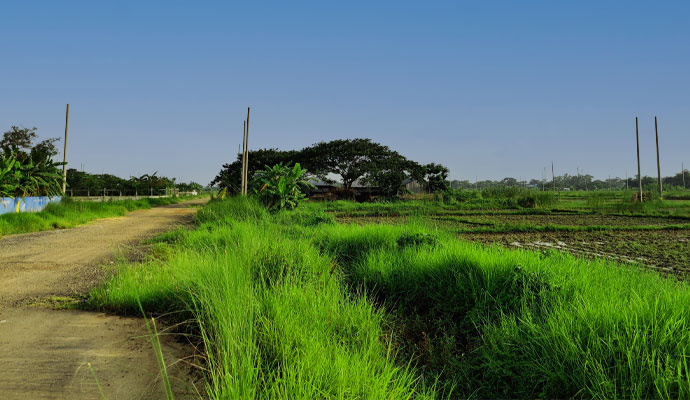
0 1 690 184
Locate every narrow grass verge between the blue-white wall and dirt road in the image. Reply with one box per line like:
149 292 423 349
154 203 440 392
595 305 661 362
0 197 199 236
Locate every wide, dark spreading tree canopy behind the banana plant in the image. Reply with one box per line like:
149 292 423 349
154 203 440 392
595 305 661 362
211 139 450 197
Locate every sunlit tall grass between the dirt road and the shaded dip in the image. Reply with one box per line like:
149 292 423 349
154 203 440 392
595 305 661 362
91 198 430 399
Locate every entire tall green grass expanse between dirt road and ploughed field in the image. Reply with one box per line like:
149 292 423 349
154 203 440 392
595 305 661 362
91 198 690 399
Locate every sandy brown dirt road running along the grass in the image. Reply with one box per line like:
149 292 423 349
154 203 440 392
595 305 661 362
0 200 204 399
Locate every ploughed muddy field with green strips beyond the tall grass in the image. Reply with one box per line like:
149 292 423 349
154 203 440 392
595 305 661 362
326 192 690 276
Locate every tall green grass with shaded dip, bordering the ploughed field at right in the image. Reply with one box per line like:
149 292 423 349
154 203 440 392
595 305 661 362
315 226 690 398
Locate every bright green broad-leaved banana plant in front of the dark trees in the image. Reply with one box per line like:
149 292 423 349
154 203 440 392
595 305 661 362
251 163 313 211
